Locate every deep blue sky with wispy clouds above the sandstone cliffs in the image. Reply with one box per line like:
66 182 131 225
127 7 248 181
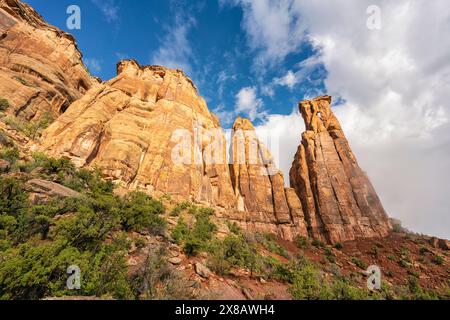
26 0 326 127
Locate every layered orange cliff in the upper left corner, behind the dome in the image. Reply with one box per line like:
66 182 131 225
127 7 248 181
0 0 98 120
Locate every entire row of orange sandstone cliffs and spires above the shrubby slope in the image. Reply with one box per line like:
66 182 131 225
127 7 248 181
0 0 391 243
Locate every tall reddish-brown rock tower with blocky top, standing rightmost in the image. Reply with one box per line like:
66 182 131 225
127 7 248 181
290 96 391 243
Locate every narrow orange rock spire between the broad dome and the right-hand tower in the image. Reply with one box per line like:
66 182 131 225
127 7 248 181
228 118 307 240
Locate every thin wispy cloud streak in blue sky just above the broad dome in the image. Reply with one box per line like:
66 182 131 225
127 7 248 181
151 14 196 74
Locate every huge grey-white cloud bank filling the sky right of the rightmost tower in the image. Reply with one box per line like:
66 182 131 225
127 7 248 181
230 0 450 238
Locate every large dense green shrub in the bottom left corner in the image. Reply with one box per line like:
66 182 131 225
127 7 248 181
0 235 130 300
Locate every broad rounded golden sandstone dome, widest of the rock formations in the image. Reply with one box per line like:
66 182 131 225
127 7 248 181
41 60 236 208
